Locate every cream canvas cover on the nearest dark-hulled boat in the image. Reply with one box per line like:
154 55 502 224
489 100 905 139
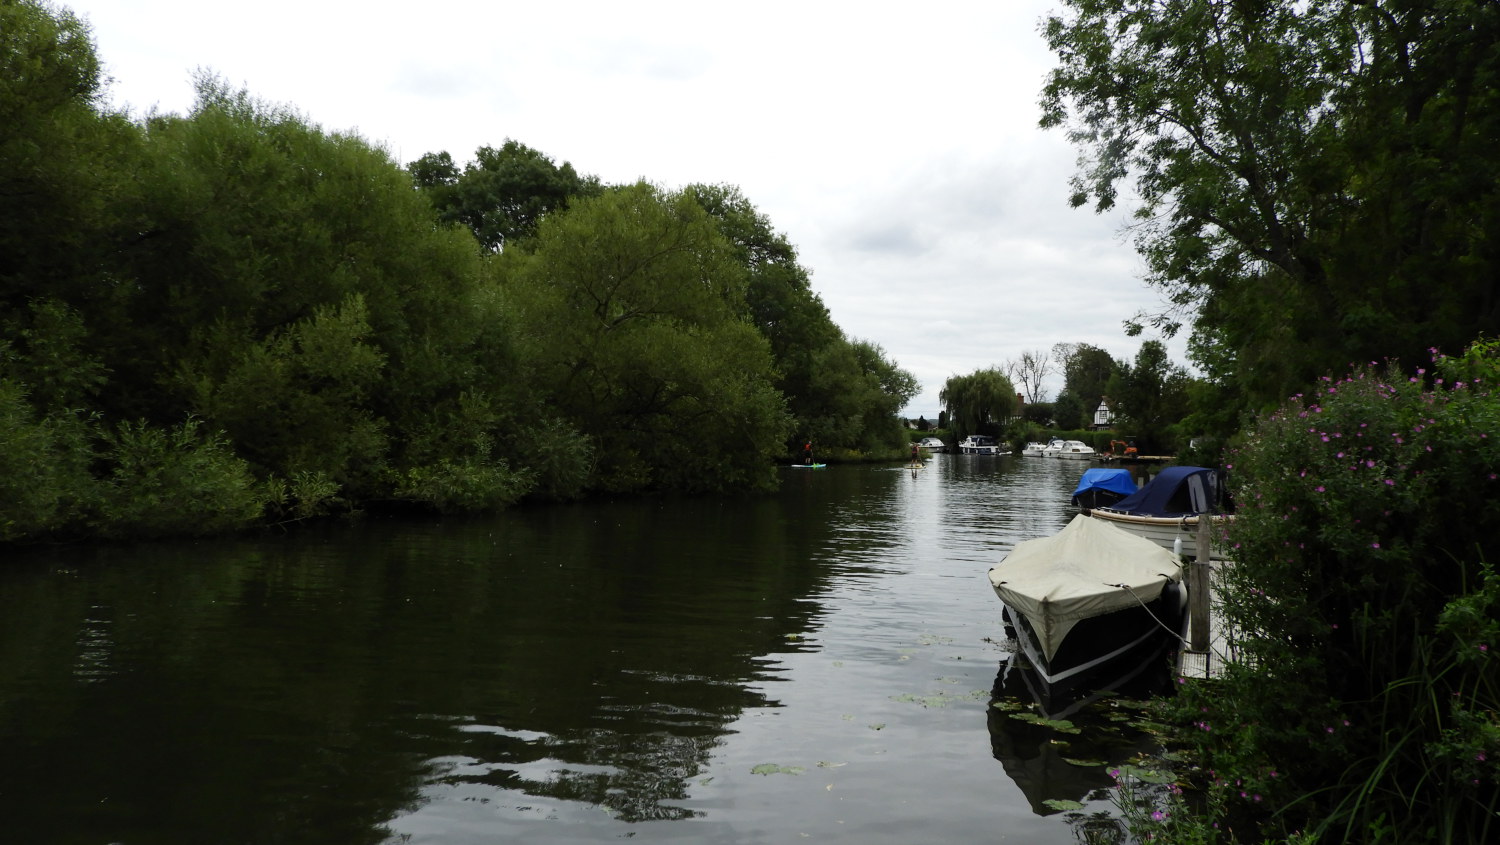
990 513 1182 660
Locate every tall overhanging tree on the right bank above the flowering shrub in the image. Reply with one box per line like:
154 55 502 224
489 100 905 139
1041 0 1500 407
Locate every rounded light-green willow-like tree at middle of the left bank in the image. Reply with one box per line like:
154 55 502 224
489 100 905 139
501 183 788 491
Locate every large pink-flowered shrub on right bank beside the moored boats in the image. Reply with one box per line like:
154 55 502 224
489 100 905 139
1134 342 1500 842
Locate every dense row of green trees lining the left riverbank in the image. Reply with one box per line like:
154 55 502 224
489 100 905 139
0 0 917 542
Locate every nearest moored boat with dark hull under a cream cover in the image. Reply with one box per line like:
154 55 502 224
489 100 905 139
990 513 1187 683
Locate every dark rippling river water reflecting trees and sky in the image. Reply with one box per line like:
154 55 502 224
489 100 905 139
0 455 1170 845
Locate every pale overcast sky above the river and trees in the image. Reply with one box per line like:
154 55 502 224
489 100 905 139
79 0 1185 419
